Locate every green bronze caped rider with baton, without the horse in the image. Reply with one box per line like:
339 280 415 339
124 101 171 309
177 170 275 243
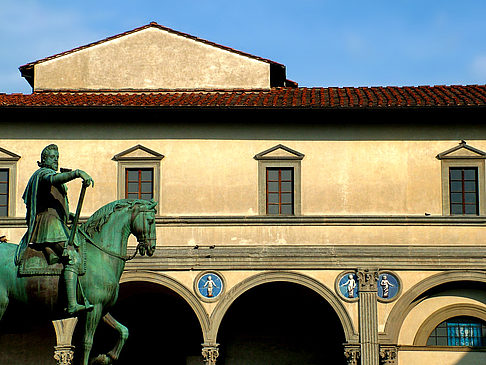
15 144 94 315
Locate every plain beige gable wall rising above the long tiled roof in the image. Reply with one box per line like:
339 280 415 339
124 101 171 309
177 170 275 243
34 28 270 91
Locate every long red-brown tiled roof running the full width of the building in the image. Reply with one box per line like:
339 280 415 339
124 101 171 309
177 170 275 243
0 85 486 109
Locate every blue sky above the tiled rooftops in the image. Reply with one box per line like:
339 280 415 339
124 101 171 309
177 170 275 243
0 0 486 94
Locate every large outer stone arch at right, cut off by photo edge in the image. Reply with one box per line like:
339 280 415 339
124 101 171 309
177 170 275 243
382 270 486 344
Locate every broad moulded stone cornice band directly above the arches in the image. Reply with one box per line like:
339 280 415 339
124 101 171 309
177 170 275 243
126 243 486 270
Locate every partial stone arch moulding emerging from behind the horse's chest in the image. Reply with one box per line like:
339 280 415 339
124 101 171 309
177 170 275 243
120 271 210 342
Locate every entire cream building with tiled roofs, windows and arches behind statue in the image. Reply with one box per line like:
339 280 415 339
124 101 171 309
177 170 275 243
0 23 486 365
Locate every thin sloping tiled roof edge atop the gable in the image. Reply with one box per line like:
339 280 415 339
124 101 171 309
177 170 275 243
19 22 280 73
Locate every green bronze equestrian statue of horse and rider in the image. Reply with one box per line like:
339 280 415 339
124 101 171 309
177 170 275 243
0 144 157 365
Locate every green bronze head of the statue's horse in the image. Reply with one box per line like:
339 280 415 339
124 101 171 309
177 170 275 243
131 201 157 256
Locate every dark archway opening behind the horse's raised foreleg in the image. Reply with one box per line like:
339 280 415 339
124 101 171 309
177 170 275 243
92 282 203 365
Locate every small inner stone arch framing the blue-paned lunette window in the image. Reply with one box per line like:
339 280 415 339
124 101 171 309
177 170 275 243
413 303 486 346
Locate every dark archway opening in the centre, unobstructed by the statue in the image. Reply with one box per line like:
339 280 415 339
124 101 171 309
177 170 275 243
218 282 346 365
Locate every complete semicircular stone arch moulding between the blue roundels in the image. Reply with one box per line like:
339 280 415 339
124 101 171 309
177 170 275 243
208 271 358 343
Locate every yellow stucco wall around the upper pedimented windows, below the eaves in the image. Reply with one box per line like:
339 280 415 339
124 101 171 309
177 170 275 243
1 138 486 246
